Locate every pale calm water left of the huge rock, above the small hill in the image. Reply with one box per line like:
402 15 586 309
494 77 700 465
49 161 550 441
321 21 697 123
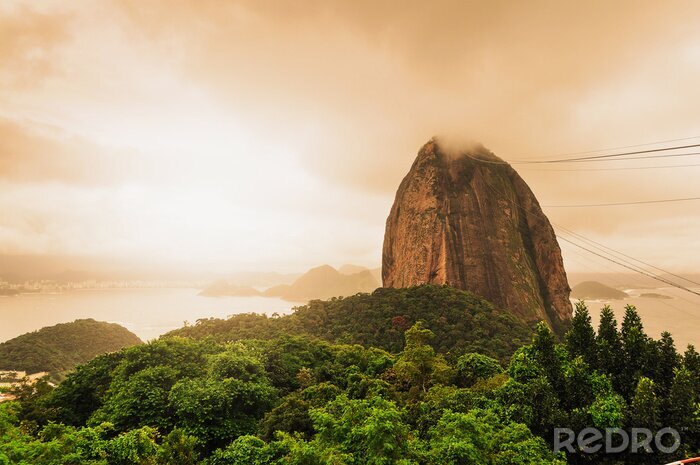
0 289 298 342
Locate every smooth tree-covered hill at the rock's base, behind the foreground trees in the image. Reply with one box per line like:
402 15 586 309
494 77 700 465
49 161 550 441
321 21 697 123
167 285 533 360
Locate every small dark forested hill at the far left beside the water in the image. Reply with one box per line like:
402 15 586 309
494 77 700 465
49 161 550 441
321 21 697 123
0 319 141 378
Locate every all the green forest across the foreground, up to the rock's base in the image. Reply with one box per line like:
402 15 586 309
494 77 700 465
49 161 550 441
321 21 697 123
0 286 700 465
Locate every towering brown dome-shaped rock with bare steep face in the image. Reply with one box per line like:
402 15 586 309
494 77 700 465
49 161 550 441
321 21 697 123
382 139 572 333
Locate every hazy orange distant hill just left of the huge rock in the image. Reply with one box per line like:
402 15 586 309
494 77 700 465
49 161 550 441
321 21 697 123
264 265 380 302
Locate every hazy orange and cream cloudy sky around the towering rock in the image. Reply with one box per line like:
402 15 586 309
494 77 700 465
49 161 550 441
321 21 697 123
0 0 700 273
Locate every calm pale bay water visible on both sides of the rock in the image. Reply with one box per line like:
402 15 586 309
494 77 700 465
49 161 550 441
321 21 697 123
0 288 700 350
